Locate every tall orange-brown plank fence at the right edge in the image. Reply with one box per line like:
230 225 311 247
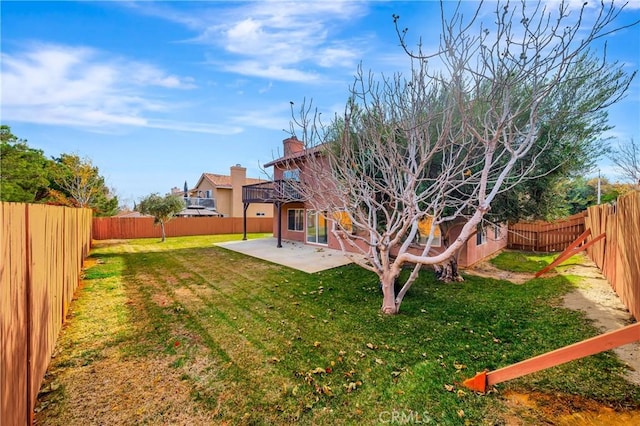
585 191 640 321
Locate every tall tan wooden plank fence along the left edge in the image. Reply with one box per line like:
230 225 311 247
0 202 92 426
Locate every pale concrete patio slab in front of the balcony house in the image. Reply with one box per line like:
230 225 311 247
216 238 352 274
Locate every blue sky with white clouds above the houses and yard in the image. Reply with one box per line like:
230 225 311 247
0 0 640 206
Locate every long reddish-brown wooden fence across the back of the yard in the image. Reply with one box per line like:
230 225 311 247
93 217 273 240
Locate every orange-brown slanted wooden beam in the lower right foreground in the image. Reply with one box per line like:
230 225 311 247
463 323 640 392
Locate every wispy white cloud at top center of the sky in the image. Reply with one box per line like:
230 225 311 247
129 1 368 82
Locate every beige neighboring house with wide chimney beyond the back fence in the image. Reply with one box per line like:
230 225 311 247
172 164 273 217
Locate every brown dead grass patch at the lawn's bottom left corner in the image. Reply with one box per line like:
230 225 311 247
36 350 211 426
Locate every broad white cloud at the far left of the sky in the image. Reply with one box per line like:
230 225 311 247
2 44 240 134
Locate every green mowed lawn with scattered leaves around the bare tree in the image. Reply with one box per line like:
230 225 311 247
39 236 640 425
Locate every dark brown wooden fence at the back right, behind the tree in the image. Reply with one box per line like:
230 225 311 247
507 212 586 253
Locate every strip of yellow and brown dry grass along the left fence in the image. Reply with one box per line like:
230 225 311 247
36 244 211 425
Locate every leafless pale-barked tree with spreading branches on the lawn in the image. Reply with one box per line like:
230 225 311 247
292 1 630 314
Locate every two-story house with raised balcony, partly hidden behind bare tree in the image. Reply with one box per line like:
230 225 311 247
243 137 507 267
